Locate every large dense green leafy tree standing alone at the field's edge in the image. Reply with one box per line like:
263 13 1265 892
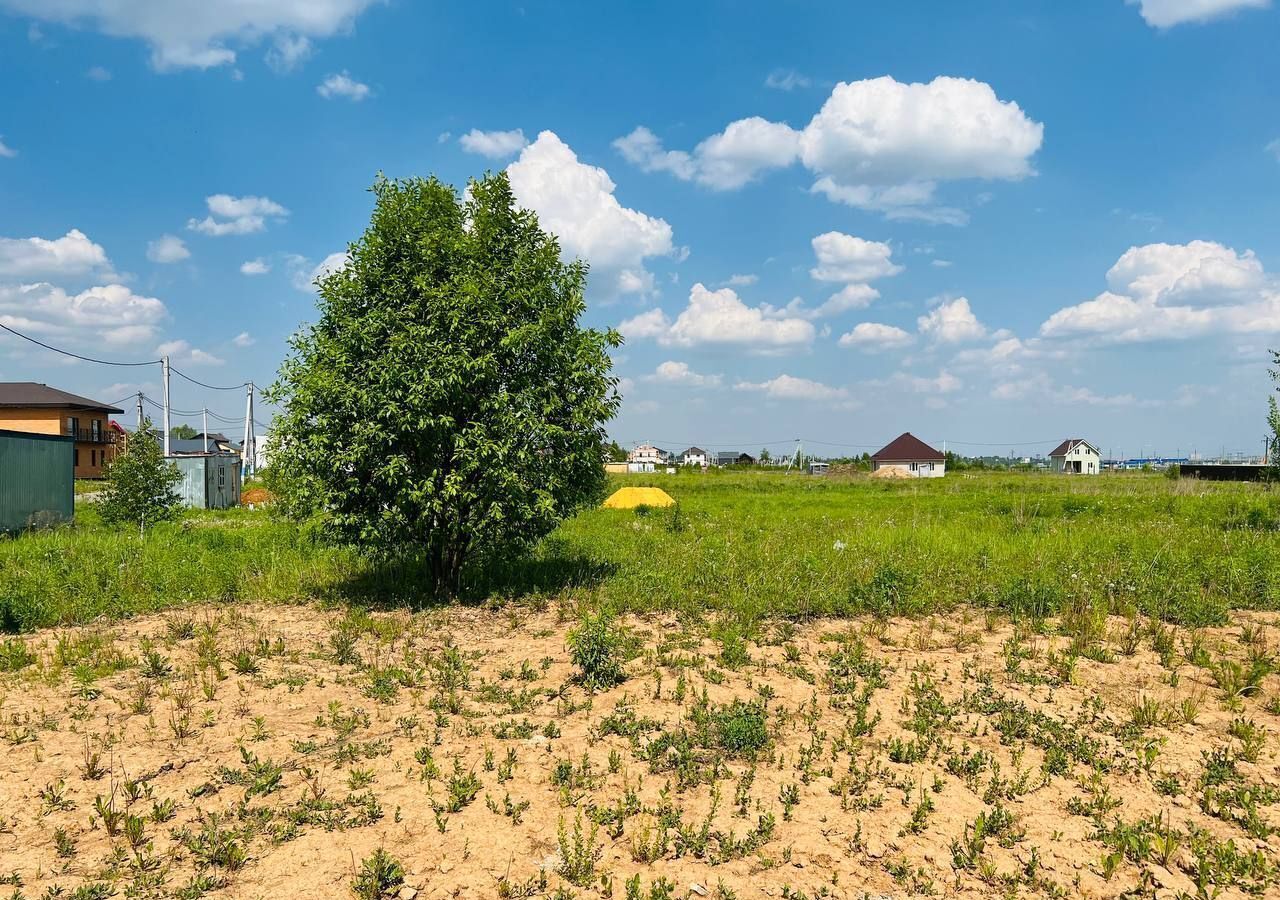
269 174 622 595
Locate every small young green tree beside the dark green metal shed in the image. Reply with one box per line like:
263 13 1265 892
97 419 182 531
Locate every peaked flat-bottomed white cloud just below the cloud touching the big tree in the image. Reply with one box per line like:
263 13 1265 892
618 283 814 352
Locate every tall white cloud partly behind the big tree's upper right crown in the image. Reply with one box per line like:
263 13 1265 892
507 131 673 294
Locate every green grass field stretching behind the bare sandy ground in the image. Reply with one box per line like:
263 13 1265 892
0 472 1280 631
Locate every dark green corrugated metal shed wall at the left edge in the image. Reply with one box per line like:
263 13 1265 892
0 431 76 531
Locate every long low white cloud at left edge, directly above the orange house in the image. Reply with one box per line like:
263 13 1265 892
0 283 168 347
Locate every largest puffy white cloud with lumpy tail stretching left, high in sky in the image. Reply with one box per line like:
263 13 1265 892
614 76 1044 224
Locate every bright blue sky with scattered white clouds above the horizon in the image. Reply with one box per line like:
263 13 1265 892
0 0 1280 454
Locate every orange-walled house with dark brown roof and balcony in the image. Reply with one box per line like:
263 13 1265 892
0 382 124 478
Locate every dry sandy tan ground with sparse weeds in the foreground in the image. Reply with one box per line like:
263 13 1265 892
0 607 1280 900
